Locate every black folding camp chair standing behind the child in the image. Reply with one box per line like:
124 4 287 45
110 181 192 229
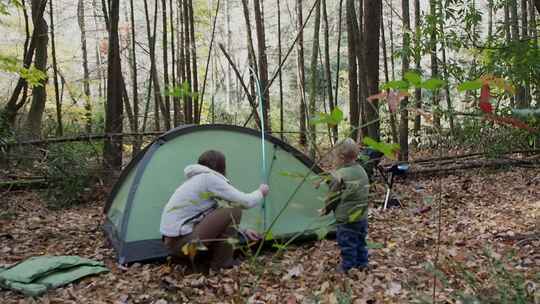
358 148 410 210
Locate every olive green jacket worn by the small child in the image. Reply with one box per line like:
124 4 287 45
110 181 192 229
323 162 369 224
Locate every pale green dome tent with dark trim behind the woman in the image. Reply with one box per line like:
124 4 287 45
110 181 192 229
104 125 331 263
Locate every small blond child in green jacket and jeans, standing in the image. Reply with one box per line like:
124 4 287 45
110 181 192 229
323 138 369 273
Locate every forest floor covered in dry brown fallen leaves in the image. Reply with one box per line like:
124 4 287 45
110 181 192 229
0 168 540 304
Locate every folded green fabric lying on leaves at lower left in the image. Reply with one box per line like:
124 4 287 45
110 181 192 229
0 256 109 297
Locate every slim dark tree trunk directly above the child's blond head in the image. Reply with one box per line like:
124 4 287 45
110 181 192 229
346 0 360 140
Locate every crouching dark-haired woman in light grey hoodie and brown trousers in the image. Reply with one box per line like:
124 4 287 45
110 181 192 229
160 150 269 269
